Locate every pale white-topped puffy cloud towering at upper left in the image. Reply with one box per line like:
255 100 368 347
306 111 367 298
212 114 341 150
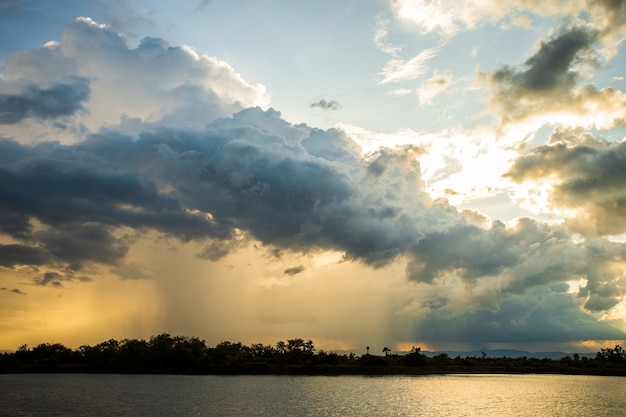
0 18 269 140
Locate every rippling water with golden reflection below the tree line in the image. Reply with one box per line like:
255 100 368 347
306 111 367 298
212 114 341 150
0 374 626 417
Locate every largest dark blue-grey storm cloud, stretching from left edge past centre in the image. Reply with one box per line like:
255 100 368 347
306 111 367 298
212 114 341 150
0 109 425 272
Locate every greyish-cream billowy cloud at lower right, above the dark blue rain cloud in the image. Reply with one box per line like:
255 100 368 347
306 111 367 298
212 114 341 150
407 214 626 311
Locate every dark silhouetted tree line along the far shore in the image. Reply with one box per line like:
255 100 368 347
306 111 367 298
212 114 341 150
0 333 626 375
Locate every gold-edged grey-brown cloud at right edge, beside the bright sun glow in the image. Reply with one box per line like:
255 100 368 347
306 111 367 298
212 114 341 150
506 129 626 235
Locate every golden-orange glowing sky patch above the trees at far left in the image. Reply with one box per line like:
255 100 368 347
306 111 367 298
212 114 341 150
0 274 161 350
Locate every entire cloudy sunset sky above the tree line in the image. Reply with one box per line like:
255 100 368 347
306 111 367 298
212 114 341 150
0 0 626 354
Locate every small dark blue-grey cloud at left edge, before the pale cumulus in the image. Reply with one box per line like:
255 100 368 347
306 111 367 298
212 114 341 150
0 77 90 124
